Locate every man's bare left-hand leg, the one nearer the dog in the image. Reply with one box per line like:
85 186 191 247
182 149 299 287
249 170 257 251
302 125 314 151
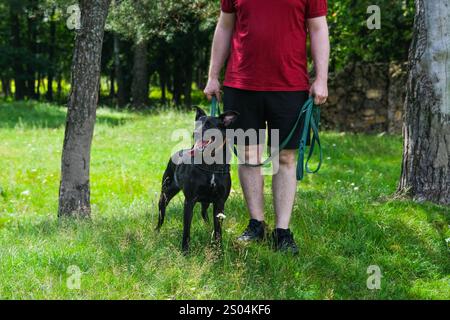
239 146 264 221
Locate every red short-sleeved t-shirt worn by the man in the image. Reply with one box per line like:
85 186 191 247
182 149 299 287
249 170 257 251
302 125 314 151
221 0 327 91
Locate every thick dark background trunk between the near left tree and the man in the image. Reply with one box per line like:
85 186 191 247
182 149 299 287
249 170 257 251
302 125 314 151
131 40 149 108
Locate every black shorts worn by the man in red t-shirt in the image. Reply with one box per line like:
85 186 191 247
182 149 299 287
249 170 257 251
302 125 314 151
223 87 310 149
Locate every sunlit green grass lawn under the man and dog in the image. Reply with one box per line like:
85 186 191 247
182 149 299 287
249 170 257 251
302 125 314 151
0 103 450 299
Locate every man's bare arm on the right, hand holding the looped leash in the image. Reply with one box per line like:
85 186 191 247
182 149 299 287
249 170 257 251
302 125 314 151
308 17 330 105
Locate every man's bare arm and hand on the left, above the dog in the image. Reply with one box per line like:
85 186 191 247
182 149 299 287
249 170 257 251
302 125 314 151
204 11 236 100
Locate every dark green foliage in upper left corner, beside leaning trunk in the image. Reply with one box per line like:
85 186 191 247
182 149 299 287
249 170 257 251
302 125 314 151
0 0 74 99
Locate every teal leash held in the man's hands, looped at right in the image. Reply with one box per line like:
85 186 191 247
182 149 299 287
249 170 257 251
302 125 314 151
211 97 323 181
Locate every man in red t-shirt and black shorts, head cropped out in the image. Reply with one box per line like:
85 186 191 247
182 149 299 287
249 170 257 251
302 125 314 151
204 0 330 254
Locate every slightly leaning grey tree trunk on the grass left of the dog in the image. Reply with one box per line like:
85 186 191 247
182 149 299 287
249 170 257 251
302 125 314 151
58 0 110 217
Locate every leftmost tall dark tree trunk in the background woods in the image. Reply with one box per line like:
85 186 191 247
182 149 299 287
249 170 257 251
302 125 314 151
10 5 25 100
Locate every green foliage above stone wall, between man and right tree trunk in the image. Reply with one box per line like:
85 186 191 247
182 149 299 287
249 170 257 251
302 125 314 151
328 0 414 70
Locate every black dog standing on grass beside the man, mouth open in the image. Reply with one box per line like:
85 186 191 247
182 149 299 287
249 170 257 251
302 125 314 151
156 108 238 253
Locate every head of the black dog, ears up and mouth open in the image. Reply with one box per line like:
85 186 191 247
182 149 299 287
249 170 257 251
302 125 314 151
194 107 239 152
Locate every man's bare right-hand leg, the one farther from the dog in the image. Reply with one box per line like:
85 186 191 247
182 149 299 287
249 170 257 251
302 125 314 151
272 150 297 229
